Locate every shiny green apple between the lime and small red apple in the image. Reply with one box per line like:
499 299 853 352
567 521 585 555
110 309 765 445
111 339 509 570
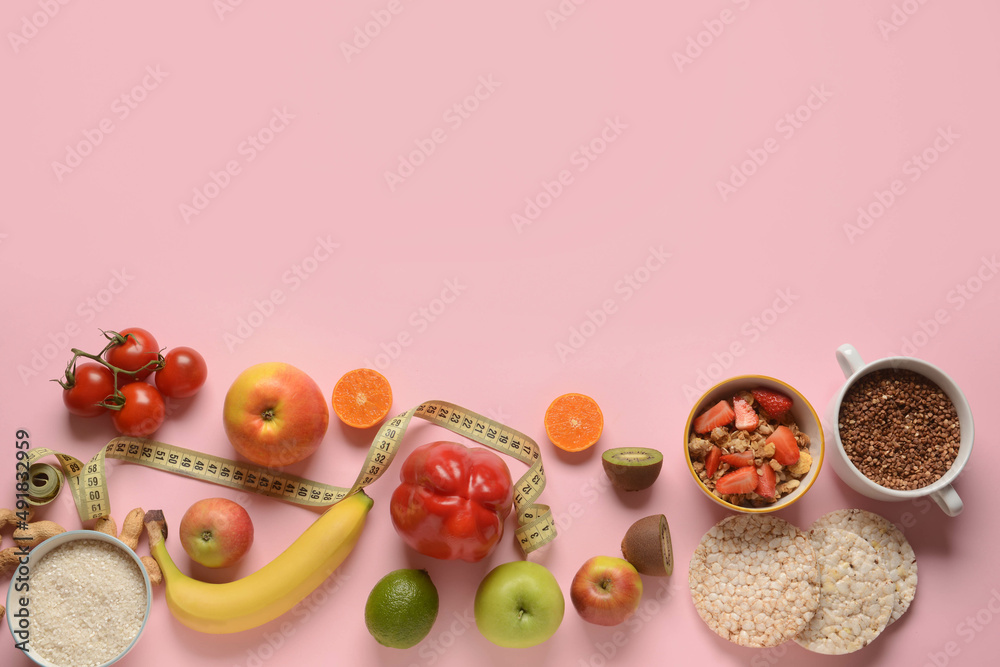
474 561 566 648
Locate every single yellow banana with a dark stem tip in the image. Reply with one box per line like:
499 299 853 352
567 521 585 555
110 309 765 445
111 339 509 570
144 491 373 634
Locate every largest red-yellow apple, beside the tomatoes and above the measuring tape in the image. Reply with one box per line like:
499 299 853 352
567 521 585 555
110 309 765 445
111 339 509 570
222 362 330 468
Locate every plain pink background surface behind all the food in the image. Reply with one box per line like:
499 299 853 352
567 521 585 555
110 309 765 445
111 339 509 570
0 0 1000 666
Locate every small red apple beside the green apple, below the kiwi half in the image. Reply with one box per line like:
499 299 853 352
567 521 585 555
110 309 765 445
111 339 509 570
569 556 642 625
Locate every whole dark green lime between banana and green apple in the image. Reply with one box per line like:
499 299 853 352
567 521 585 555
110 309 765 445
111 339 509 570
365 569 438 648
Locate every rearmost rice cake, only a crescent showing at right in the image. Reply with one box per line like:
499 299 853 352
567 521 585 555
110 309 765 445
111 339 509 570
812 509 917 624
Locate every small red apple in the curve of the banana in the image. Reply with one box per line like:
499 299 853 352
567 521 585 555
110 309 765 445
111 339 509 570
180 498 253 567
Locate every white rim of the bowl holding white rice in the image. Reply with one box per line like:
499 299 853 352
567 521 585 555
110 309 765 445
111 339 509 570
7 530 153 667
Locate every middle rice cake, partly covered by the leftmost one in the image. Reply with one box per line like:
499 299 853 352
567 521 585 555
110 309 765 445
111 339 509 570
795 527 896 655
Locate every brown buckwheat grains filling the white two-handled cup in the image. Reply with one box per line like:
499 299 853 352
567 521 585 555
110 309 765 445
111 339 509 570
838 369 961 491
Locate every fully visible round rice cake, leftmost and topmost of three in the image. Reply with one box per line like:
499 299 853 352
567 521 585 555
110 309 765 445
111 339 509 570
688 514 819 648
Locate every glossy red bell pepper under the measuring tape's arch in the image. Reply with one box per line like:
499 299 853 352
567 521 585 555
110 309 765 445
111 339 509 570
389 441 514 563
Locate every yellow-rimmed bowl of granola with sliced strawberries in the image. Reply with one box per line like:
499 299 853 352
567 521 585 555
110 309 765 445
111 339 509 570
684 375 824 513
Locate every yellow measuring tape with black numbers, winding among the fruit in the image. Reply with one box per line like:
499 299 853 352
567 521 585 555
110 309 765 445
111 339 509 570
28 401 556 554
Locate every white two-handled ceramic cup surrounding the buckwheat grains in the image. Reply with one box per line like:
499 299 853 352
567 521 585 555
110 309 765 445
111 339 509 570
827 345 975 516
